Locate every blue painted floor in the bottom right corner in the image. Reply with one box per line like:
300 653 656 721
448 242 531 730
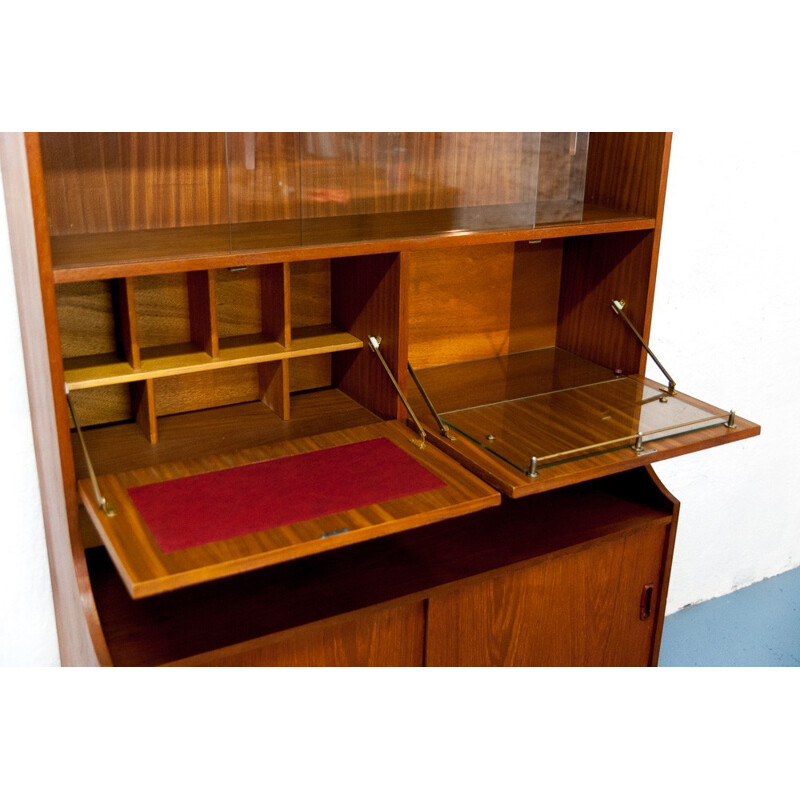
658 568 800 667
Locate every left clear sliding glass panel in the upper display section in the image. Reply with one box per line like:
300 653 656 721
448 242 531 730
228 132 541 250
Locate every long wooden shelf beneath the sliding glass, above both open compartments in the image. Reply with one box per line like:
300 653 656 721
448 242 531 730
51 205 655 283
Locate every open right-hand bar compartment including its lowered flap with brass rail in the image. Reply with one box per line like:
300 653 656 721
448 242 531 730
407 231 758 497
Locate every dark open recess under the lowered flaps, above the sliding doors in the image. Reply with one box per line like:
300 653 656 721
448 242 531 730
87 468 675 666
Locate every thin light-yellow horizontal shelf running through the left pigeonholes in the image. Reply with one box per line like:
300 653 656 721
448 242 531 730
64 325 363 390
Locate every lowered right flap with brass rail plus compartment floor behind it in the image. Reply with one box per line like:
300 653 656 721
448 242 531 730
409 347 757 490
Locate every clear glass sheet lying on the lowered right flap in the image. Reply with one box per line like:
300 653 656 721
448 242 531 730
442 378 728 472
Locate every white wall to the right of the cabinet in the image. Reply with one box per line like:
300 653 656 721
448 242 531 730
648 127 800 613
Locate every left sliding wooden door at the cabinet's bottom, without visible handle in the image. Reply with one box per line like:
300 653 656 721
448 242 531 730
175 601 425 667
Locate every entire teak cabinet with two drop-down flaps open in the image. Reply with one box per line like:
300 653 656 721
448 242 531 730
0 133 759 666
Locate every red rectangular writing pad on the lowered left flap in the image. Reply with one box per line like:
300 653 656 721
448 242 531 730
128 438 445 553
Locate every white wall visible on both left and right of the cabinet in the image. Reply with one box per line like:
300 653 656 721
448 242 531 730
0 129 800 665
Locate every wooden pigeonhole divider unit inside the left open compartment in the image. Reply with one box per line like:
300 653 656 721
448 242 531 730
59 260 363 444
